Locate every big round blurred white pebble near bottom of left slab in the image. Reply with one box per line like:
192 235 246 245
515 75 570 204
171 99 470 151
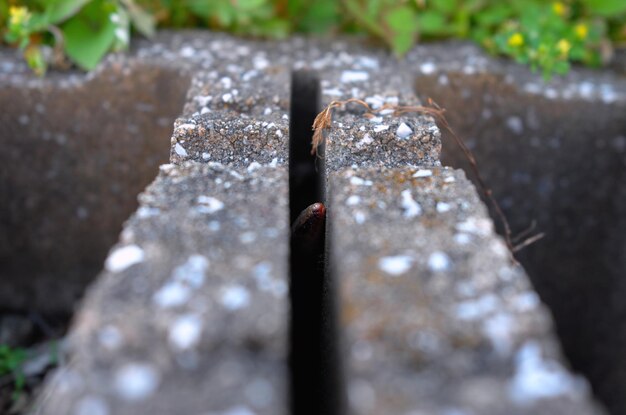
114 363 161 401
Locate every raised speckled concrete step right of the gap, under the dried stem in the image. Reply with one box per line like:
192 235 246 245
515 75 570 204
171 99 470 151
294 39 440 170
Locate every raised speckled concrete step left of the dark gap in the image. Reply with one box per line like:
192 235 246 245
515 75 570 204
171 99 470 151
171 39 291 166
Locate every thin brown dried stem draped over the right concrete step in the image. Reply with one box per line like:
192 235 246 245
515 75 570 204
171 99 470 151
311 98 544 253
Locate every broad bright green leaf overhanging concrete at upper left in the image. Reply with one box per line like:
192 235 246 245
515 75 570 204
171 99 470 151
61 0 117 70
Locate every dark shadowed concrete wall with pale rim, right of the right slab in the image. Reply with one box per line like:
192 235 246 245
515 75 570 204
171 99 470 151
408 43 626 413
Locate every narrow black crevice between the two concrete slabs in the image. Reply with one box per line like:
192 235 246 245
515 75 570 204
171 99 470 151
289 72 337 415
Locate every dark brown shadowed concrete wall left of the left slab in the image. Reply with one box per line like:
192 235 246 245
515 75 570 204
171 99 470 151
0 50 189 315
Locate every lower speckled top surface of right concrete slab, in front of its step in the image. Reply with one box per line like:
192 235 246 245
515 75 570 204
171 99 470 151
328 167 600 415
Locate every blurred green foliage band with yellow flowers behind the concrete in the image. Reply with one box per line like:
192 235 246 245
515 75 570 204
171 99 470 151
0 0 626 78
